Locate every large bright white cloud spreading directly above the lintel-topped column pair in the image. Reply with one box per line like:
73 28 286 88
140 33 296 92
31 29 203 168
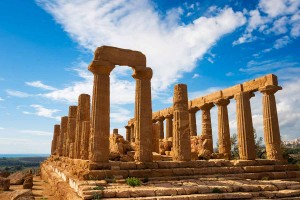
38 0 245 90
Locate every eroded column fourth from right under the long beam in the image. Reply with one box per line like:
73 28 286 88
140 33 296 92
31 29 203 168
200 103 214 153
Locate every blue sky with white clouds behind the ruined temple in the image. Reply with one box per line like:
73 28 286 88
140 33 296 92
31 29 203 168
0 0 300 153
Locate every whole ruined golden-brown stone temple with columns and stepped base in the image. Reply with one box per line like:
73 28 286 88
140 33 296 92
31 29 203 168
41 46 300 200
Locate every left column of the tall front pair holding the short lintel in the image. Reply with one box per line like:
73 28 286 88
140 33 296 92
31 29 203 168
89 61 114 162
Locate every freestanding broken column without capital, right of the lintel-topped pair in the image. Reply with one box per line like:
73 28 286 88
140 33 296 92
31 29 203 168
173 84 191 161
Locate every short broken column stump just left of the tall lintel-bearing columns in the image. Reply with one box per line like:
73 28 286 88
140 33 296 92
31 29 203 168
81 121 91 160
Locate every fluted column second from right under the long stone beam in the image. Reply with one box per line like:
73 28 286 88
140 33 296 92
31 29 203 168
234 92 256 160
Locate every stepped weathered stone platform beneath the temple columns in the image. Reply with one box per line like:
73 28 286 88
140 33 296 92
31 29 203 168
41 156 300 199
